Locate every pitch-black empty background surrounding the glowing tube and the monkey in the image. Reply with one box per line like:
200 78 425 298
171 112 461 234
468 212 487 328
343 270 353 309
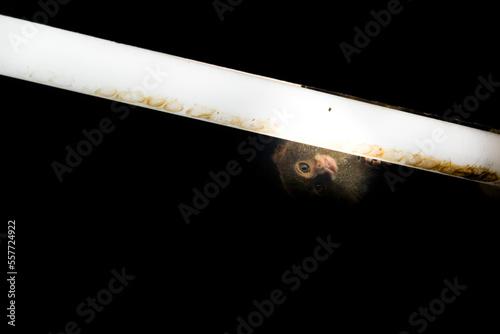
0 0 500 334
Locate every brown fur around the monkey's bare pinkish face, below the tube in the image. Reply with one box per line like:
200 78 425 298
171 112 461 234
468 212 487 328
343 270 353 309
272 141 373 203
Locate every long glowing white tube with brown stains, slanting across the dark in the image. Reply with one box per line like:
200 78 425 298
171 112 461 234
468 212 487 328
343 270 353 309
0 15 500 184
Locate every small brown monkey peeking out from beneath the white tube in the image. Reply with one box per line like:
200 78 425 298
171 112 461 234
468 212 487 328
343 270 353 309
272 141 381 204
